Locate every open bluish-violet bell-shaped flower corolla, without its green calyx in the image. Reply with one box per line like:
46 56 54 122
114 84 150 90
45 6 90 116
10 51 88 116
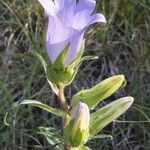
38 0 106 67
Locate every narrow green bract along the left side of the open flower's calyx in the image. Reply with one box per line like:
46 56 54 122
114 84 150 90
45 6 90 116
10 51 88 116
31 51 59 95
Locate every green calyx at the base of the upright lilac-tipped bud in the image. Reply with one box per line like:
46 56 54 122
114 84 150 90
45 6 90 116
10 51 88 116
64 120 89 147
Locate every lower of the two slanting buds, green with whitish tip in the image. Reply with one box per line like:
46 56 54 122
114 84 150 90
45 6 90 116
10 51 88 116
90 97 134 138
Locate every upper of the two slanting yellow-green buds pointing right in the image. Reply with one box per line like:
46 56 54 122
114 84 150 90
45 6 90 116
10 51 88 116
71 75 124 109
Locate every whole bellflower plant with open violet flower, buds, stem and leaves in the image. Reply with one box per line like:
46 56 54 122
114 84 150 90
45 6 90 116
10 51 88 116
18 0 133 150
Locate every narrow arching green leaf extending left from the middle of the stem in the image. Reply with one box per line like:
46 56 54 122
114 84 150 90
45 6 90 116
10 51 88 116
20 100 66 117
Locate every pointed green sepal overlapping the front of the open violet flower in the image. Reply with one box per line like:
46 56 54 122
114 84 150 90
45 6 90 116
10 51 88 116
53 44 70 70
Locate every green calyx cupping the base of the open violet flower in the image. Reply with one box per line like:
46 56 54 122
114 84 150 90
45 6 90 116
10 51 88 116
48 44 83 86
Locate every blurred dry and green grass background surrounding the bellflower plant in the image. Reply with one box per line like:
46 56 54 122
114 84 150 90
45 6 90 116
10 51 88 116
0 0 150 150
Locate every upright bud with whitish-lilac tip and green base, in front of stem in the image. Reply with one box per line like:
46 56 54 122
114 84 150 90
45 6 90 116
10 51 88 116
65 102 90 147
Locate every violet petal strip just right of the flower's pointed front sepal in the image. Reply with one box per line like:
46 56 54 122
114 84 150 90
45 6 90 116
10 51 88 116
64 30 85 67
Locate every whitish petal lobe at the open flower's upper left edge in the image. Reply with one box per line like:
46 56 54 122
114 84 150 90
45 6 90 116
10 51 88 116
38 0 58 16
